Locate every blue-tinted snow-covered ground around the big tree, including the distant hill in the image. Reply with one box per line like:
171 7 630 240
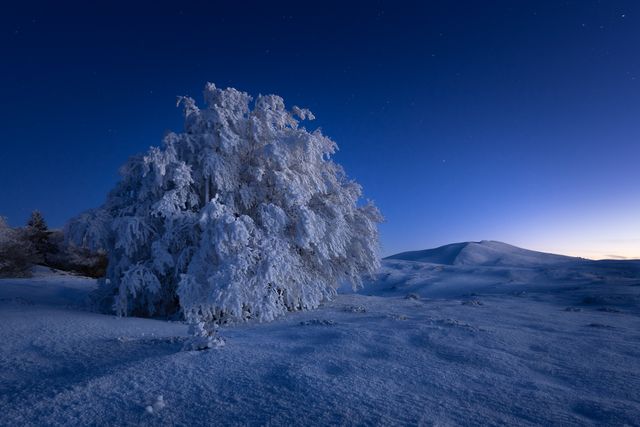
0 242 640 426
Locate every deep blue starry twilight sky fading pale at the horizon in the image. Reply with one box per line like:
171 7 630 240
0 0 640 258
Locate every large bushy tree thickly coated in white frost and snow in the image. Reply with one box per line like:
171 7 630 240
67 83 381 332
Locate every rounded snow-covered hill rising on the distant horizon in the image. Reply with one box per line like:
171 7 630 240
385 240 584 267
